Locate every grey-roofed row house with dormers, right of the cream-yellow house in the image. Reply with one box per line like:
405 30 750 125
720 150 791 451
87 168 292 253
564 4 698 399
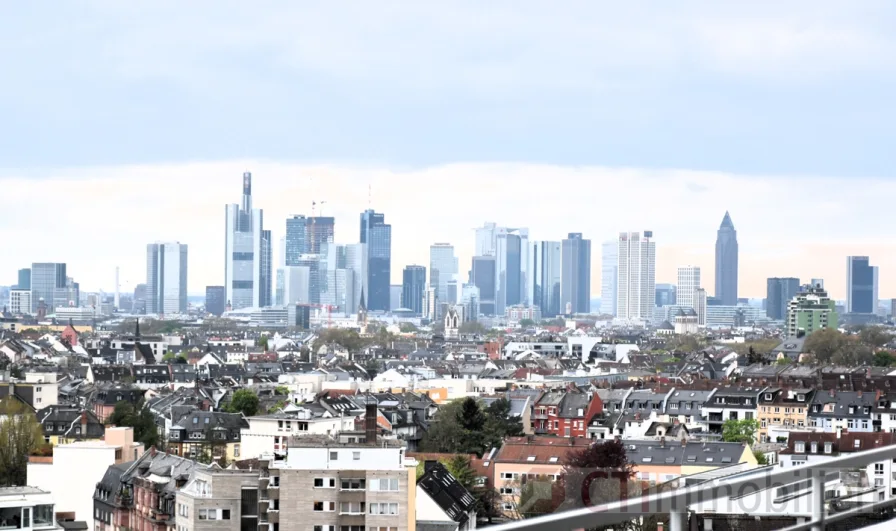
806 389 880 432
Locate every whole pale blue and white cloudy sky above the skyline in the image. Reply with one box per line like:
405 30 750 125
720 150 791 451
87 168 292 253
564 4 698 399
0 0 896 304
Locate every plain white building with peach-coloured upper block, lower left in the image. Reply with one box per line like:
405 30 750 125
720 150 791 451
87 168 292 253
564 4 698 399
28 427 143 529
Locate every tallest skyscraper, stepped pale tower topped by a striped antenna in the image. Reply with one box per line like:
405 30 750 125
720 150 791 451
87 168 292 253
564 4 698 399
224 172 273 310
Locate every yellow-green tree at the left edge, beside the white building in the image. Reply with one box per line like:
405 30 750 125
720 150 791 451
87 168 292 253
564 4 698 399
0 398 44 487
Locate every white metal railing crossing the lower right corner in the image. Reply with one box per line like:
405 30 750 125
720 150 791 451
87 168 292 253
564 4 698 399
489 445 896 531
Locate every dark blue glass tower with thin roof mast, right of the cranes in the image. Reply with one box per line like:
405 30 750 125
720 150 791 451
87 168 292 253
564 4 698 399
361 209 392 312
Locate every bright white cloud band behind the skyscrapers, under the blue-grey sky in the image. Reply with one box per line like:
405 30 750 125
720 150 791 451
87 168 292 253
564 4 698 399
0 160 896 297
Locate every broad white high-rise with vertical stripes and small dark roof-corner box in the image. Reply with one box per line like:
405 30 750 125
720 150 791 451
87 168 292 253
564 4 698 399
616 231 656 322
